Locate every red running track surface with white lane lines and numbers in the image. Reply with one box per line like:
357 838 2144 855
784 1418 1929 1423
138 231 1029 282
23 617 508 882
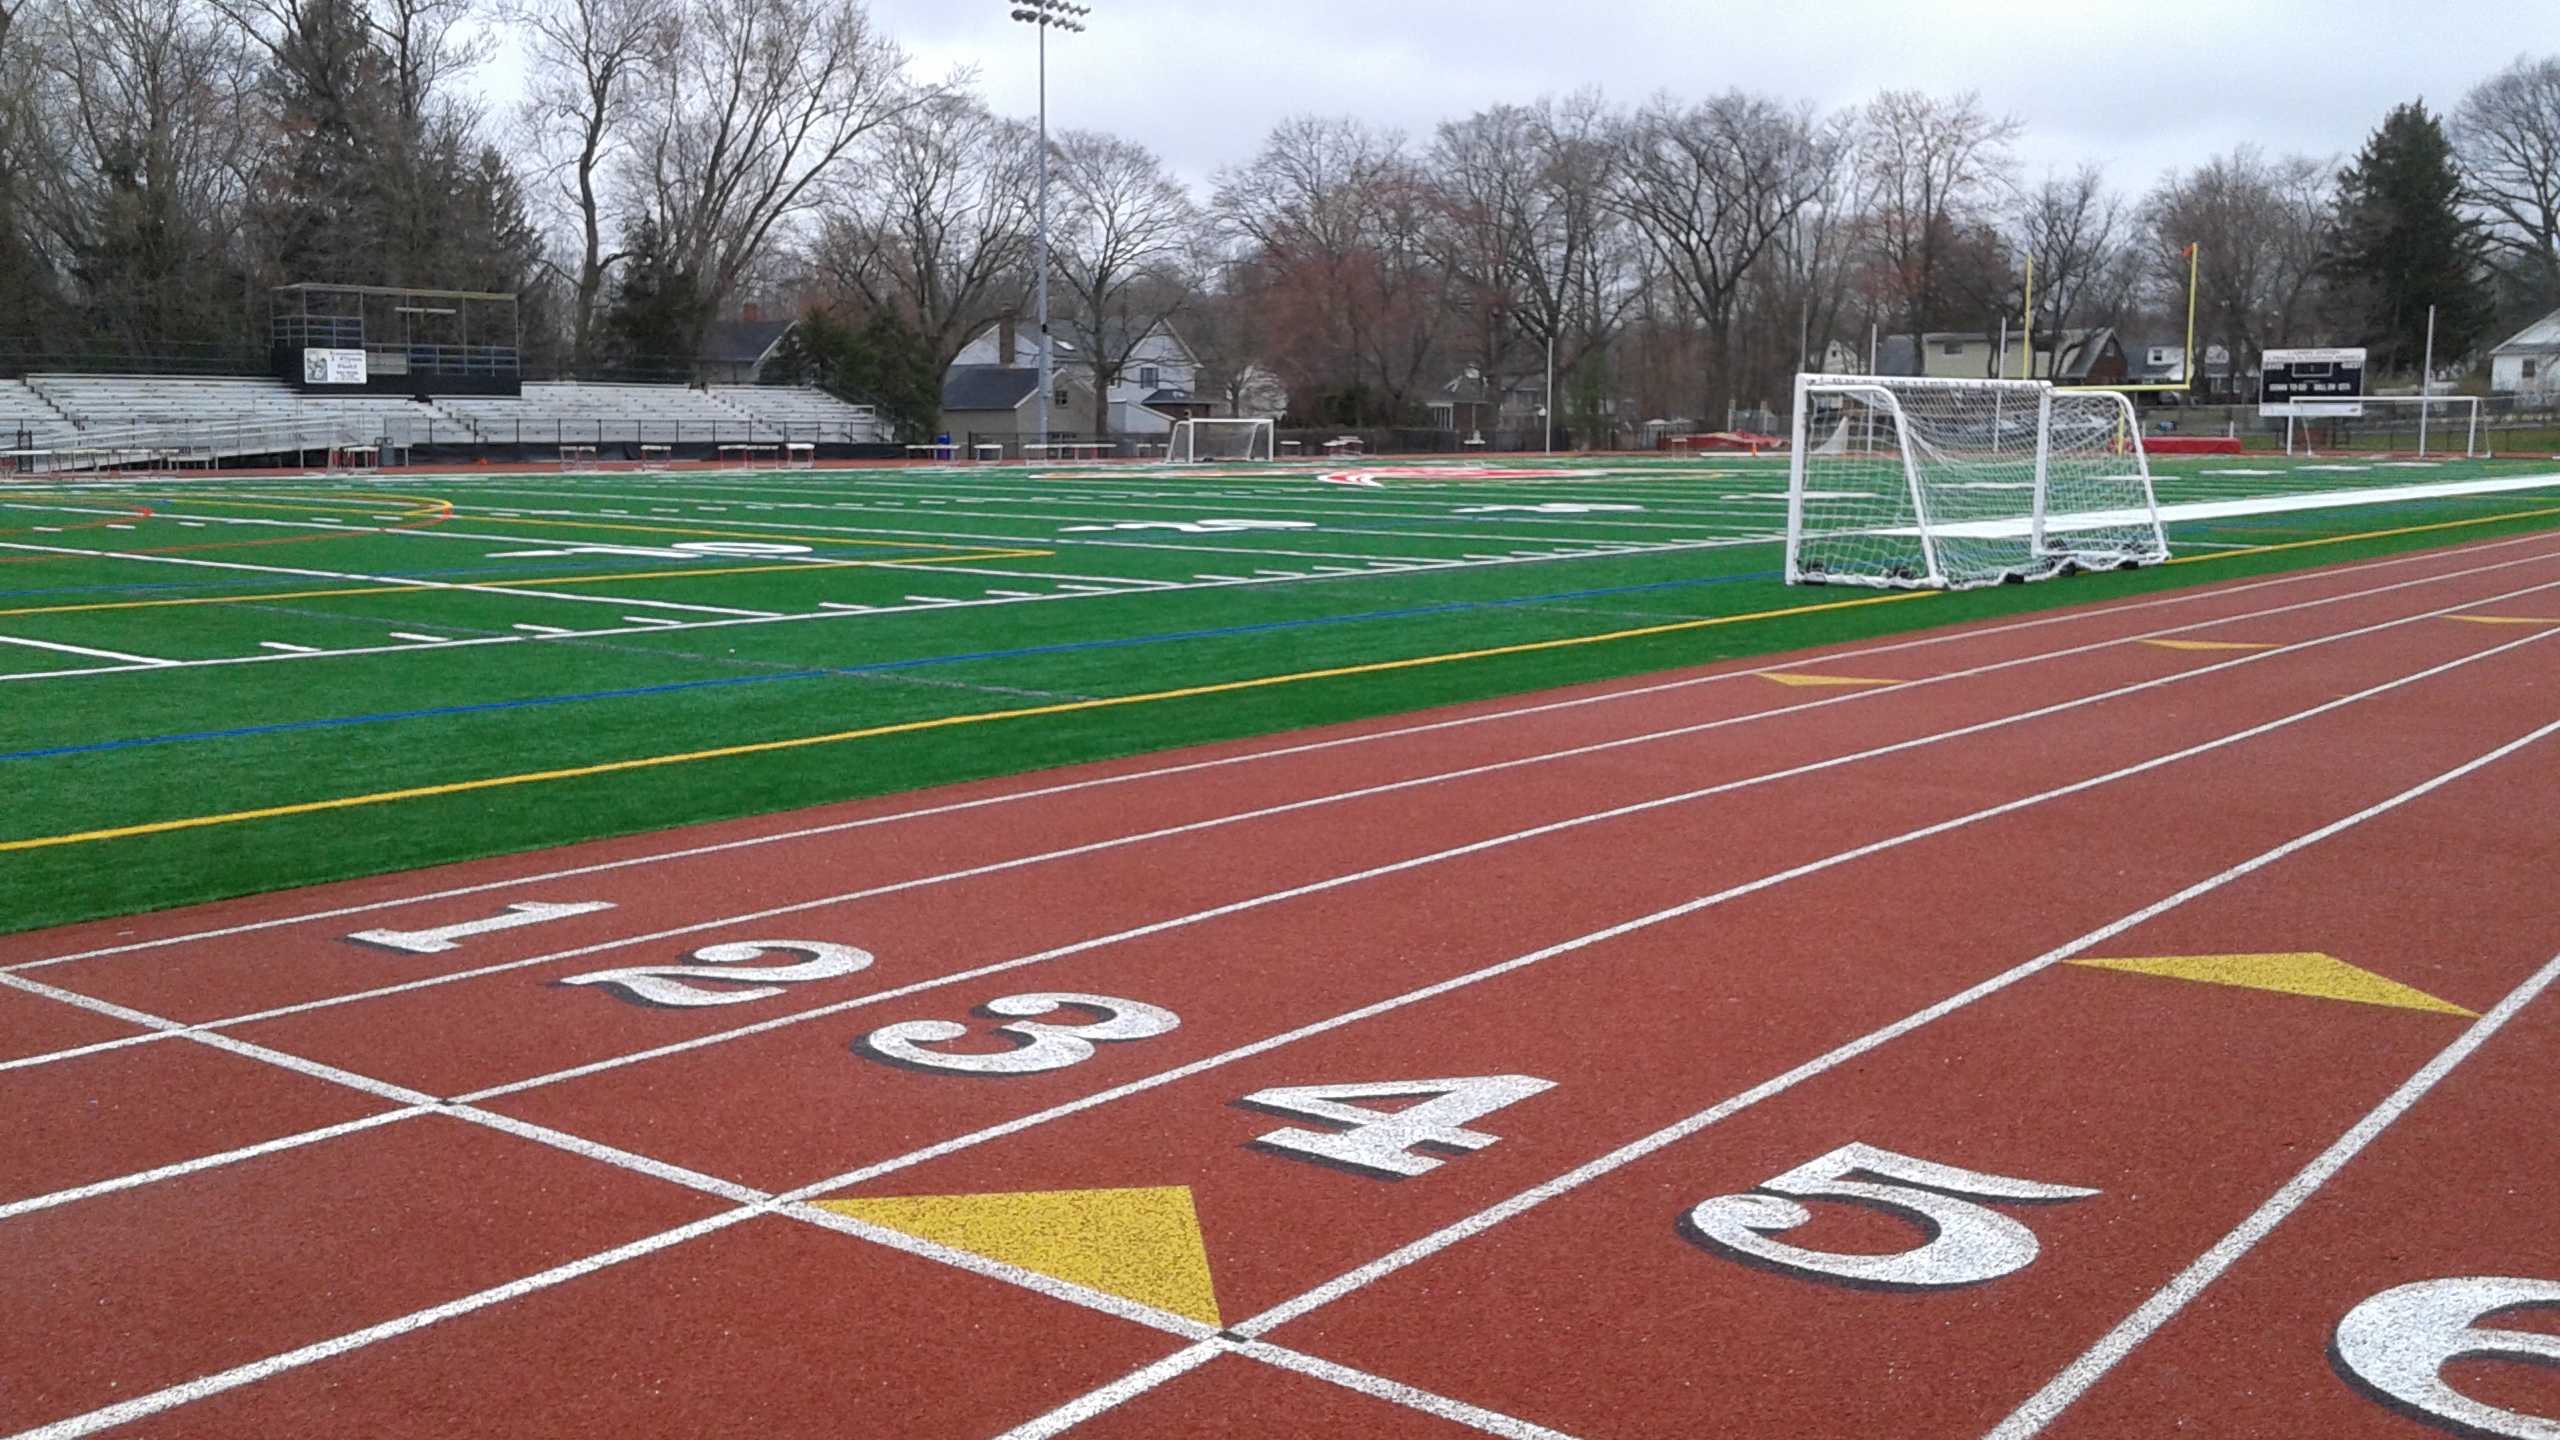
0 536 2560 1437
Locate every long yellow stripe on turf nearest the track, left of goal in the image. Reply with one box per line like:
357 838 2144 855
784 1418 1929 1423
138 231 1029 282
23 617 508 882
0 589 1938 853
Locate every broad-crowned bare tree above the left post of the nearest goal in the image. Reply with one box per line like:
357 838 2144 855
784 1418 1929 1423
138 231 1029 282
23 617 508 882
1613 90 1838 415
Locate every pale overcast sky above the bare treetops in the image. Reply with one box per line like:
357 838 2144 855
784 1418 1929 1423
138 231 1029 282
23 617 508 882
484 0 2560 190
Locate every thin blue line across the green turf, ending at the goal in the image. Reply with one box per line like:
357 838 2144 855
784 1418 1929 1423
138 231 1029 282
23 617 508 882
0 569 1782 761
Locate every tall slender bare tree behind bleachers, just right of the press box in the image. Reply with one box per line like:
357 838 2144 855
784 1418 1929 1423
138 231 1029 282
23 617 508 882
507 0 678 366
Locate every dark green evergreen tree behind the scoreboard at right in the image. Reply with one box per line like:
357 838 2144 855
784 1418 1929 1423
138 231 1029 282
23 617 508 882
2330 100 2493 369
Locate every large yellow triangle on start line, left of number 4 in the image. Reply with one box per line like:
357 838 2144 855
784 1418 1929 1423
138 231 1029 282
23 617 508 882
814 1184 1224 1325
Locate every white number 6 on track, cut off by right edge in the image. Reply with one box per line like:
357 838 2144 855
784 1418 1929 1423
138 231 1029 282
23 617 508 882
2335 1276 2560 1440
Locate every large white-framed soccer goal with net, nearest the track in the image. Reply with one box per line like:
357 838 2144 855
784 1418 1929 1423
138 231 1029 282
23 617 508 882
1787 374 2168 589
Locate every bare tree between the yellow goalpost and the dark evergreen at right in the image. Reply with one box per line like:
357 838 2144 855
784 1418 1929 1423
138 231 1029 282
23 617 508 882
2148 146 2337 374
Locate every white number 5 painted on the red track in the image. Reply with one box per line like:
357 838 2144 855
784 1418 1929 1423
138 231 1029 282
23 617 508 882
1687 1143 2097 1289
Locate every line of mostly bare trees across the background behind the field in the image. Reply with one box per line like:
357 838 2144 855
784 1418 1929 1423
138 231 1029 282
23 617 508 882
0 0 2560 438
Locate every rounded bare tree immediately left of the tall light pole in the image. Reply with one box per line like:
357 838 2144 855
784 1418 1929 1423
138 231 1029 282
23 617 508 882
812 92 1039 374
